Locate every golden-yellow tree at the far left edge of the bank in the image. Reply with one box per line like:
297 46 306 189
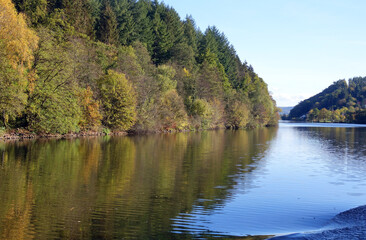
0 0 38 126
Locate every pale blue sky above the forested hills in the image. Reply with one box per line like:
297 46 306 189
163 0 366 106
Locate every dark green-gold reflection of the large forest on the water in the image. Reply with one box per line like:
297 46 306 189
0 129 277 239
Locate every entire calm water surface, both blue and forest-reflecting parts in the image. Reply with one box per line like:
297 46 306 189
0 123 366 239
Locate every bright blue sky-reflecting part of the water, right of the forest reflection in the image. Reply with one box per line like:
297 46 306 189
179 124 366 236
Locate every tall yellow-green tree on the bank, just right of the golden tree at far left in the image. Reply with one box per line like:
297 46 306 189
27 28 82 134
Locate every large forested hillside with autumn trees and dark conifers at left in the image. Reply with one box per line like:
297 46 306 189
0 0 278 134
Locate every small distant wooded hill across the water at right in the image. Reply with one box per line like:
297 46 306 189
288 77 366 123
